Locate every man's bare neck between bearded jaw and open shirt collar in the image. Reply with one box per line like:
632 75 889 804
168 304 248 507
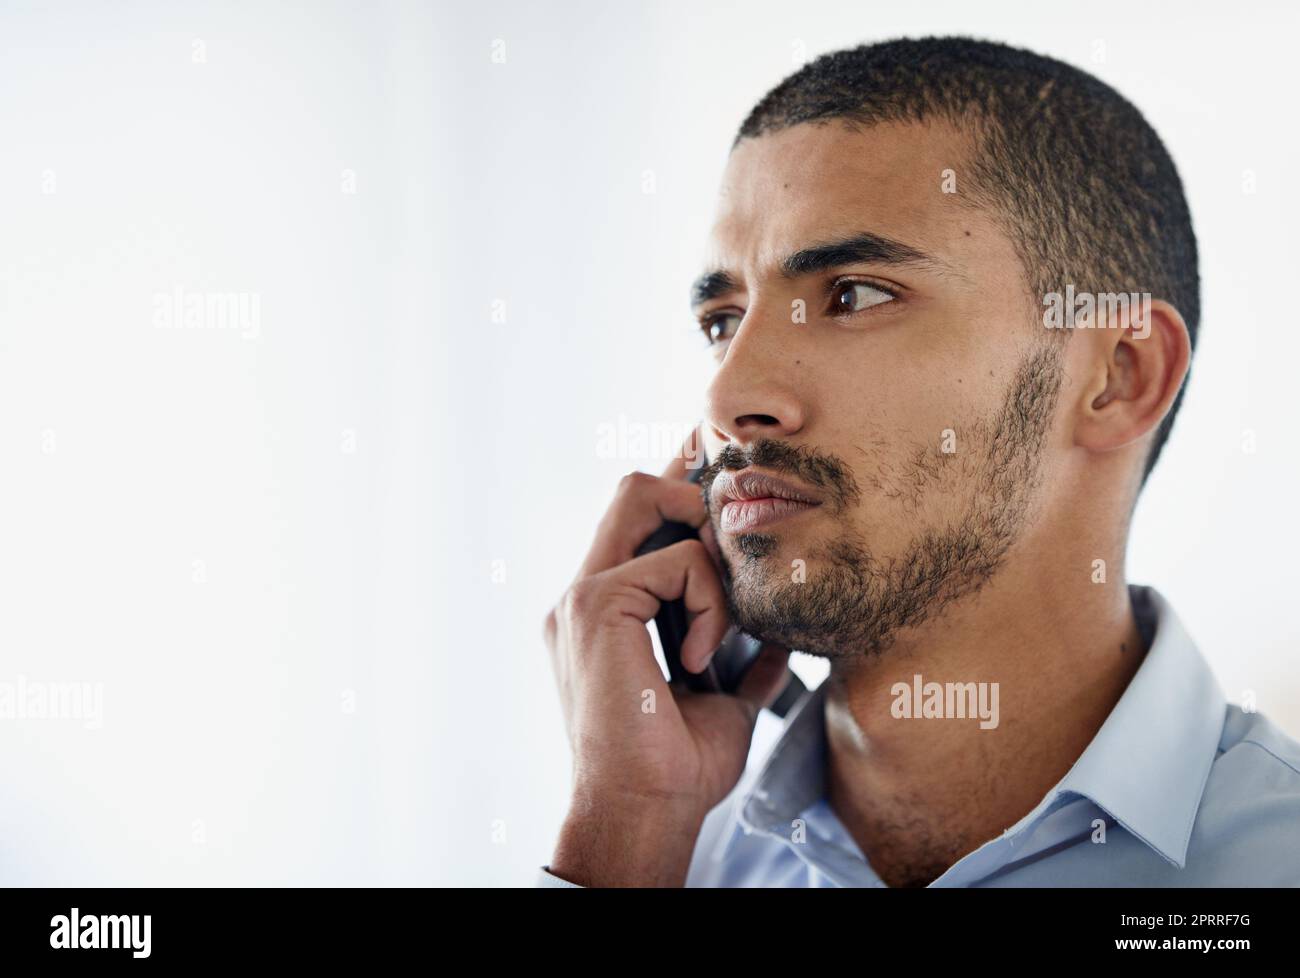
826 567 1145 886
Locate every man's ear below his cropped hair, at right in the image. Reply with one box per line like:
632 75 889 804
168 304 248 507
1075 299 1192 451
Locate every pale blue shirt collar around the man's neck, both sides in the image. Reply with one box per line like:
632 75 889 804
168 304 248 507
727 585 1226 869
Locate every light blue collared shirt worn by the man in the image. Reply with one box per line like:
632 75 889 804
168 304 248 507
537 585 1300 887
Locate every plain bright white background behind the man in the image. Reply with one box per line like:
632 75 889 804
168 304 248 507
0 3 1300 884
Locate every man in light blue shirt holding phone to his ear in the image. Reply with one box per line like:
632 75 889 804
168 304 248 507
540 38 1300 887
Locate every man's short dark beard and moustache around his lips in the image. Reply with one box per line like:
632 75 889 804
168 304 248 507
701 341 1063 659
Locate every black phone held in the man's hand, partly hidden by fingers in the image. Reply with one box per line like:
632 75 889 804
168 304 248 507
637 466 807 717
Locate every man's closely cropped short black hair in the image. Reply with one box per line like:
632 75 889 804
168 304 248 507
732 36 1200 484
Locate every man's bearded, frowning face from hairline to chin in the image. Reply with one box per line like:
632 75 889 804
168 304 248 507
694 122 1061 655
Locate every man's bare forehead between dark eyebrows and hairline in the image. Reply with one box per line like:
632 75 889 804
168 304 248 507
709 121 975 275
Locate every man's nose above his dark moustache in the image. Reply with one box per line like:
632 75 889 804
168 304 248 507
705 306 807 445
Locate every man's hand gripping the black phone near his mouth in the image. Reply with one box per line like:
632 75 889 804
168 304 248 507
546 436 789 886
